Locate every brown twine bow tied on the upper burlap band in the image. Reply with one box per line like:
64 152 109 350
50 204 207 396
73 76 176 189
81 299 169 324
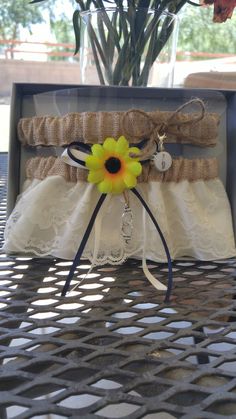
122 98 205 160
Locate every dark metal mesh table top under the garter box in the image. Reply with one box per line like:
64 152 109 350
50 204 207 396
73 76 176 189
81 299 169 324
0 154 236 419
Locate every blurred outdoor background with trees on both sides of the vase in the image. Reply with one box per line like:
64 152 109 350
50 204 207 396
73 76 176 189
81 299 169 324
0 0 236 152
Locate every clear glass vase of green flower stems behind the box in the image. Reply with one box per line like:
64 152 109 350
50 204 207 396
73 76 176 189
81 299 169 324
31 0 236 87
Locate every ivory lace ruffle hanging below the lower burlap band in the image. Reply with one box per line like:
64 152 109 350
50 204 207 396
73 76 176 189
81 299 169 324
4 175 236 264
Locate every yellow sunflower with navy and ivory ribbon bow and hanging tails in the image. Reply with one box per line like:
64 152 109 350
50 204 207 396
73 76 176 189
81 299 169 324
62 136 173 302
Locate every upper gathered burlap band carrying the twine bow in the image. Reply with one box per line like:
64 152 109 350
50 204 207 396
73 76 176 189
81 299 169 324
18 111 219 147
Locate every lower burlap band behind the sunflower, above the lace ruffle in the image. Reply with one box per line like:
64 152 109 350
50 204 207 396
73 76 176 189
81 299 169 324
26 156 218 183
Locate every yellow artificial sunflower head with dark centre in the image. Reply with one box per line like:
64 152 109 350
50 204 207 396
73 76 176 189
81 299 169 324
85 136 142 194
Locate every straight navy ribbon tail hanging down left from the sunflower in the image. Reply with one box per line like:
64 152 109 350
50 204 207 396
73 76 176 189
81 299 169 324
61 194 107 297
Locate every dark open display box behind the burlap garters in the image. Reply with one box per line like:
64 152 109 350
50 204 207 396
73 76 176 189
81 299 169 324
7 83 236 238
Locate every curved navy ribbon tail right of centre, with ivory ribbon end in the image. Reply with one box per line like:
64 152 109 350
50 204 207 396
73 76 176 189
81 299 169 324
131 188 173 303
